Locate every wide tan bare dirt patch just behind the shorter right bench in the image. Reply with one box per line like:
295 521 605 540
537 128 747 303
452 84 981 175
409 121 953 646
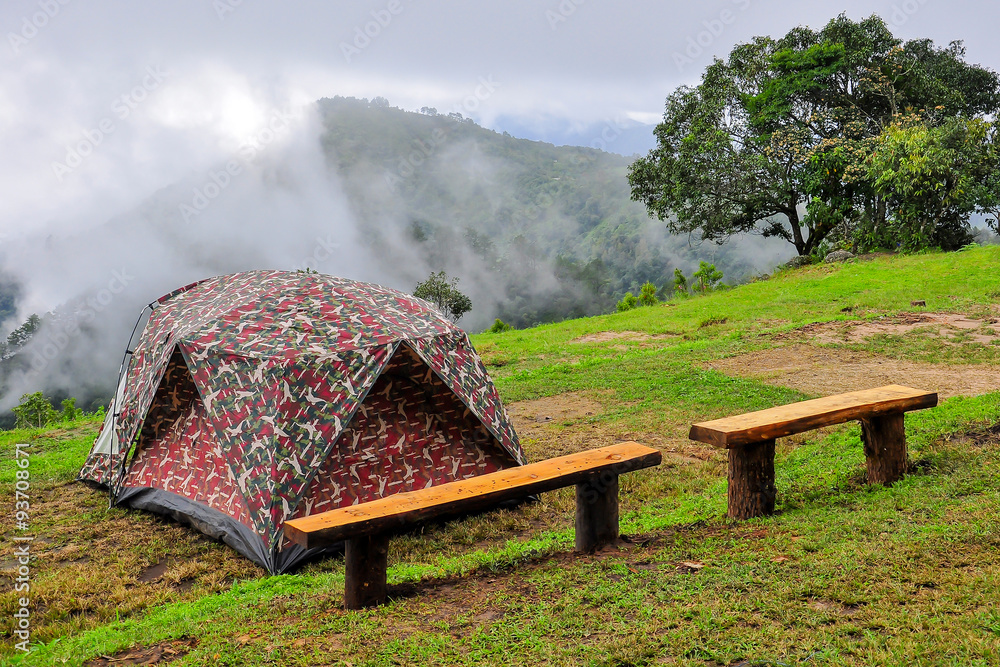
705 344 1000 398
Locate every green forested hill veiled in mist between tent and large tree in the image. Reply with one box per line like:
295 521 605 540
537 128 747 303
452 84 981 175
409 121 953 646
319 97 788 328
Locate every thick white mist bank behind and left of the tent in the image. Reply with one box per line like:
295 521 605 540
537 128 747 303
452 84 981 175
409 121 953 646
0 97 379 409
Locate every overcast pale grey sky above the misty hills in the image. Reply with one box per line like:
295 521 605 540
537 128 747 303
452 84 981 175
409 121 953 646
0 0 1000 236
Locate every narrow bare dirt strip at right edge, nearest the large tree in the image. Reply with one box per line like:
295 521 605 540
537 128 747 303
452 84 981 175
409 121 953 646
793 313 1000 345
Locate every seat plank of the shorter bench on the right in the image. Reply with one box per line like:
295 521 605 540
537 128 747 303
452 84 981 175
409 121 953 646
688 385 938 448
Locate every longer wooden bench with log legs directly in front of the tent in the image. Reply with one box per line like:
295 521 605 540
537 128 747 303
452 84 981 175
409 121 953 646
284 442 661 609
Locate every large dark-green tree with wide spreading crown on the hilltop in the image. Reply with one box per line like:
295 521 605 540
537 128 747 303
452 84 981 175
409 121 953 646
629 15 1000 255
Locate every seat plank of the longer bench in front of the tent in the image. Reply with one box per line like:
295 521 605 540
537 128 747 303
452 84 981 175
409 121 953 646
284 442 662 548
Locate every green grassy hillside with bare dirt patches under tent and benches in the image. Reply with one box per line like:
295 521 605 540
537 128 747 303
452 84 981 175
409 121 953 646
0 247 1000 666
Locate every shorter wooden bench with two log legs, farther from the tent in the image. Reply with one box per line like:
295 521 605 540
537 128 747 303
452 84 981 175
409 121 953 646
688 385 937 519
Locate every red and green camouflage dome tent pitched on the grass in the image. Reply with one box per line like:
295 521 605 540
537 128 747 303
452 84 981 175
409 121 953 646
80 271 524 573
